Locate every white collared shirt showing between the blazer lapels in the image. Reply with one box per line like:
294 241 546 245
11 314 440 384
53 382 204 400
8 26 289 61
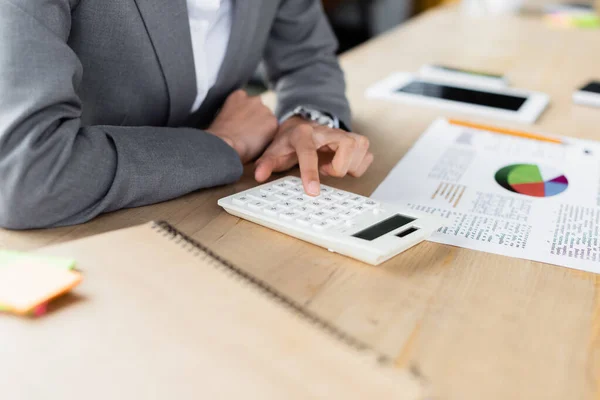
187 0 232 112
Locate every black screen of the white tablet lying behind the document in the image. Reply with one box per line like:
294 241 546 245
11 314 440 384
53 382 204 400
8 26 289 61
396 80 527 111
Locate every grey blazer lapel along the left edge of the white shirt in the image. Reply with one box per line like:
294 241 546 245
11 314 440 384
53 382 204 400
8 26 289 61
135 0 195 126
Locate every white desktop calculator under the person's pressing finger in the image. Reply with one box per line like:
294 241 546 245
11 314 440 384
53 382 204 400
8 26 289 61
219 177 442 265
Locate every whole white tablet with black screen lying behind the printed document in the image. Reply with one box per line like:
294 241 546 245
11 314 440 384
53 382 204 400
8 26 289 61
367 73 550 123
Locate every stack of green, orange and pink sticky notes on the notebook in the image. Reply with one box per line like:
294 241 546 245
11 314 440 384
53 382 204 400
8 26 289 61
0 251 82 316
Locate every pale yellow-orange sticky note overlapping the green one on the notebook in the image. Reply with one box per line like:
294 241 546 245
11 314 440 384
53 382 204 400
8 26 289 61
0 260 82 314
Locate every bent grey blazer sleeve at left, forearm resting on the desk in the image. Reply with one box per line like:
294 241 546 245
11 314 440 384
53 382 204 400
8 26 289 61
0 0 242 229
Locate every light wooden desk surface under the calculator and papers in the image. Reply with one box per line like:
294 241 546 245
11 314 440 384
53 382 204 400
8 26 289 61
0 9 600 399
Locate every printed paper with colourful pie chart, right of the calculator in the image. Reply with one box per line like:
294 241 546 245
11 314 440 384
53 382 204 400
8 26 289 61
371 120 600 273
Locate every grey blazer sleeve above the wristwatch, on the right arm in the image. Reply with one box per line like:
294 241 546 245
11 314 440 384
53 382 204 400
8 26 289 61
264 0 351 127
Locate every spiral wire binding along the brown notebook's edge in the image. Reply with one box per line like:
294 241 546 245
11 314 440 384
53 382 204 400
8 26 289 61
152 221 391 364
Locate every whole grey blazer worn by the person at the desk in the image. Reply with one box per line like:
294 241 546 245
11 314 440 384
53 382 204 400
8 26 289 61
0 0 350 229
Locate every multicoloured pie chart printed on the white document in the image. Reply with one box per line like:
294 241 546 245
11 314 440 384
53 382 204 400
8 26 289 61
496 164 569 197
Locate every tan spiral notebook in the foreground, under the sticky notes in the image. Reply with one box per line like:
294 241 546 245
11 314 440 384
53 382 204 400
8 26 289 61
0 222 426 400
